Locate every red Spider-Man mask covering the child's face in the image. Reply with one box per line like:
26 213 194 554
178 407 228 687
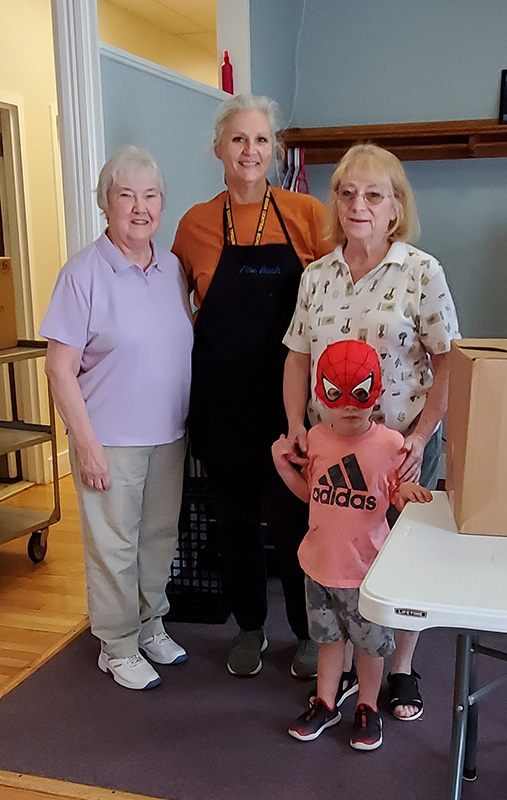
315 339 382 408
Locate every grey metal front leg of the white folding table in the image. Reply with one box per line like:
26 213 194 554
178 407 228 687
447 633 472 800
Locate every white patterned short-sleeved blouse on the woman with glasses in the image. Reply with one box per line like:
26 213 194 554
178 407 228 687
283 242 460 433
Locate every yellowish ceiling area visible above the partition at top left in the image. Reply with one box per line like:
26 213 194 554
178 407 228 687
111 0 216 55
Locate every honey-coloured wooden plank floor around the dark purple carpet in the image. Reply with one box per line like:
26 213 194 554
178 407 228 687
0 476 165 800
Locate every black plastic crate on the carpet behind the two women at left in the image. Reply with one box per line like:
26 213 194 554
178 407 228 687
166 455 229 623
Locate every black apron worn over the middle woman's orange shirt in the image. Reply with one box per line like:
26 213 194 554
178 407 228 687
189 186 302 466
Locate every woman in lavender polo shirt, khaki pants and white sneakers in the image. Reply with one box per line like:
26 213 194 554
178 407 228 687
40 147 192 689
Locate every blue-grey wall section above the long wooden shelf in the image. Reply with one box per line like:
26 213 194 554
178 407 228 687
296 0 507 126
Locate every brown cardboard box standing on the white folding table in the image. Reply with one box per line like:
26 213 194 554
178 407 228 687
446 339 507 536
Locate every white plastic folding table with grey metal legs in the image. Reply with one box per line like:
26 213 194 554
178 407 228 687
359 492 507 800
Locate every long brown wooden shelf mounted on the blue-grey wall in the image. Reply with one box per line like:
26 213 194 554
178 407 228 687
282 119 507 164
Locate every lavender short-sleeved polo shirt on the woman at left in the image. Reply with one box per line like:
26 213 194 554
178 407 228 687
40 234 193 447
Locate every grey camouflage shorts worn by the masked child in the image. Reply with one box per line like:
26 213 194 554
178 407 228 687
305 575 394 656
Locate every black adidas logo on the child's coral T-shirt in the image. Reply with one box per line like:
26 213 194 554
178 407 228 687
312 453 377 511
